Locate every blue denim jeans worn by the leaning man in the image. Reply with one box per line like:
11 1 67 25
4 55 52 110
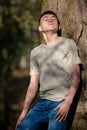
16 99 73 130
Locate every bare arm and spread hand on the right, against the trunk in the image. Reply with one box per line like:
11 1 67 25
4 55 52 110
55 65 80 121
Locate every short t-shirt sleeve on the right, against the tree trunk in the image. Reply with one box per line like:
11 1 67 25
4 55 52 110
69 40 81 65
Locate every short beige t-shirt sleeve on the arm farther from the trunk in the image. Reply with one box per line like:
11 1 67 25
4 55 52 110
30 52 39 75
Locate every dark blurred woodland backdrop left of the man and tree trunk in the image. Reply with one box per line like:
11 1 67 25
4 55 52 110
0 0 41 130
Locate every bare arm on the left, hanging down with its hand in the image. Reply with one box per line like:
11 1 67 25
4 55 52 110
16 75 39 127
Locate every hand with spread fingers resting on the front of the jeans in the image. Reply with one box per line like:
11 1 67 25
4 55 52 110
54 101 70 121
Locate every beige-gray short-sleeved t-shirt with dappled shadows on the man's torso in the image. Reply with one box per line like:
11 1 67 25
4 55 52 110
30 37 81 101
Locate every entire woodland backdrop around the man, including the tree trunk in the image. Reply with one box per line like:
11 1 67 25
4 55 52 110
0 0 87 130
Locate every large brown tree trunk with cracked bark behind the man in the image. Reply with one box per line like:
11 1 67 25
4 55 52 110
42 0 87 130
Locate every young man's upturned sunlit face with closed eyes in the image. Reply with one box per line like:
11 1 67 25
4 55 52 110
39 14 59 32
